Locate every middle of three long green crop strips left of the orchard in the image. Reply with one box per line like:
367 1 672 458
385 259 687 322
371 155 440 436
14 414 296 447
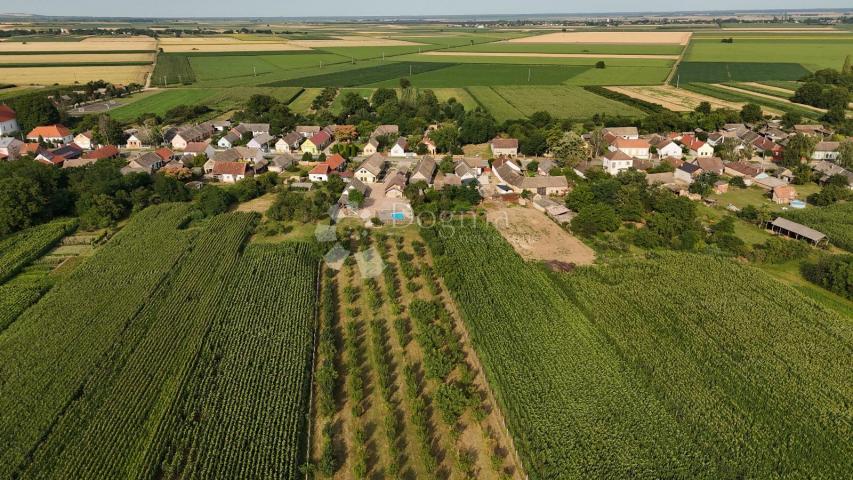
23 214 255 478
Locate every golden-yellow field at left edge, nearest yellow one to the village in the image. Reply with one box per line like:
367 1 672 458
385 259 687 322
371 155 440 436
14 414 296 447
0 66 150 85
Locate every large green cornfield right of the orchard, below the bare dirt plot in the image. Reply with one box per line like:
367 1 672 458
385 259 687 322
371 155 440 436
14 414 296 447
428 224 853 478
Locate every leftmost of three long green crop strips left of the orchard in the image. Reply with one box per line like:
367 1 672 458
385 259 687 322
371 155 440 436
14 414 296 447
0 205 192 478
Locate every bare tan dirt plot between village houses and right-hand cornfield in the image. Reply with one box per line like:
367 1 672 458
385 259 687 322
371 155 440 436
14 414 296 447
486 204 595 265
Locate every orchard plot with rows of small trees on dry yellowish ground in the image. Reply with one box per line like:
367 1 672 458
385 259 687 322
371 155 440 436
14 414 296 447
312 231 523 479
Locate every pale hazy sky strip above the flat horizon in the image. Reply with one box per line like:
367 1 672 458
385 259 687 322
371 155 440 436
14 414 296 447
8 0 851 17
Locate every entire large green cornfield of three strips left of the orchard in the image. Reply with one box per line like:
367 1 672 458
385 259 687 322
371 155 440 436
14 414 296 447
0 204 317 478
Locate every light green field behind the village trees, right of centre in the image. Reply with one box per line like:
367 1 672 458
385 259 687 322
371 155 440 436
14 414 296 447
493 86 645 118
